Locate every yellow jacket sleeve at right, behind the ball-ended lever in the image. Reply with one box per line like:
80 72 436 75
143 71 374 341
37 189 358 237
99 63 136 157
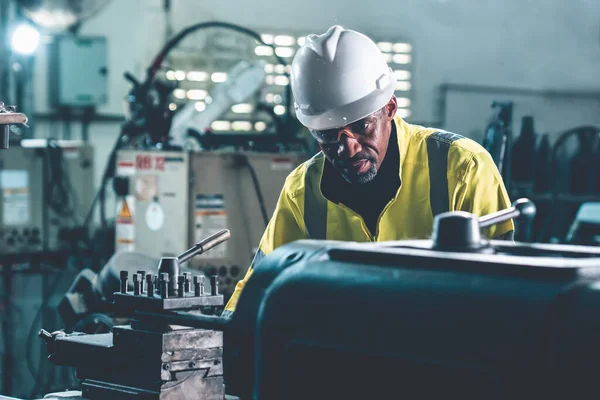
449 151 515 239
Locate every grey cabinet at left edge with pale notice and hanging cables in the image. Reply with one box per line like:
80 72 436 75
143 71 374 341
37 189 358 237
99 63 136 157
0 139 94 254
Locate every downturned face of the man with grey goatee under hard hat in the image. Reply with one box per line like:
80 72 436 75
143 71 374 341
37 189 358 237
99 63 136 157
319 97 397 184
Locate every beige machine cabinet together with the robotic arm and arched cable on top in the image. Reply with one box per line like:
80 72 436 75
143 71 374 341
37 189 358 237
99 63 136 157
95 22 308 299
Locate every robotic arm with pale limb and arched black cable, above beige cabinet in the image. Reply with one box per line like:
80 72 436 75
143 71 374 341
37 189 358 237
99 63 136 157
119 22 300 150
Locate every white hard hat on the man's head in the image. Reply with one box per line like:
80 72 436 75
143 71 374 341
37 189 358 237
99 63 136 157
291 25 396 130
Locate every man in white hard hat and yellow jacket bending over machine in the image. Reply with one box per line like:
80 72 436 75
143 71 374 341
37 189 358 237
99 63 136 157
224 26 514 316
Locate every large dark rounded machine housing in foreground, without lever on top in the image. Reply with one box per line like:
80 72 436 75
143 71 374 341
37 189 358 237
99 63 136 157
224 234 600 400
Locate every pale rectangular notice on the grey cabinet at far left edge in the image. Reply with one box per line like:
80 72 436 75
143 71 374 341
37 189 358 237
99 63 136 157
0 170 31 225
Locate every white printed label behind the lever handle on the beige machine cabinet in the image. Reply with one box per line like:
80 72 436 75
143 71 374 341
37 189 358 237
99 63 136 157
195 194 227 258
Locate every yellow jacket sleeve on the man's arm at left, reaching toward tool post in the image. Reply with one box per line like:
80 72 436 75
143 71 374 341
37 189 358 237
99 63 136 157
223 178 308 316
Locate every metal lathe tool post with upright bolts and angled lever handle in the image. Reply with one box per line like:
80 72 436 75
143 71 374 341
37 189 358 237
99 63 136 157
40 230 230 400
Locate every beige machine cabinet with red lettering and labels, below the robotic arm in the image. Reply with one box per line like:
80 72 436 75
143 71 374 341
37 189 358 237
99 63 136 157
114 149 306 297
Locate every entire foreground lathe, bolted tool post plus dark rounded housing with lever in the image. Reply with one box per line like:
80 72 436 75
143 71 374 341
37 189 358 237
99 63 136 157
22 200 600 400
